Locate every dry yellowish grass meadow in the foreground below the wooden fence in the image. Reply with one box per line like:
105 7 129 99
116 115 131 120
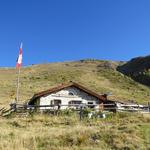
0 114 150 150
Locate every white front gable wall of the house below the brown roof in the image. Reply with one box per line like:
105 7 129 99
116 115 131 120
40 87 99 109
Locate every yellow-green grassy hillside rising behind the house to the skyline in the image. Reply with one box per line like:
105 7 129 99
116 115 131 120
0 60 150 106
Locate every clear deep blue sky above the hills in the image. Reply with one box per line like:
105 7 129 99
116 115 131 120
0 0 150 67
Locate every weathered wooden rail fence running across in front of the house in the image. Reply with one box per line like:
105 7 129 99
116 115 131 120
0 103 150 120
